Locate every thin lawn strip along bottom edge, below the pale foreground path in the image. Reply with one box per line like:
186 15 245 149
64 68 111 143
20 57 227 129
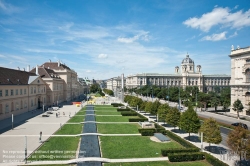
104 161 210 166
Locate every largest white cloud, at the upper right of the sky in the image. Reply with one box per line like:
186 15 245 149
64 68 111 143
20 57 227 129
183 7 250 32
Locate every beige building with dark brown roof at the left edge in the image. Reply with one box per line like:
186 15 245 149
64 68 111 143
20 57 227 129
0 67 47 120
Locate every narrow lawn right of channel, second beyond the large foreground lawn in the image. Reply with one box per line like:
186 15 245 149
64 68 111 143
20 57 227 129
96 116 139 122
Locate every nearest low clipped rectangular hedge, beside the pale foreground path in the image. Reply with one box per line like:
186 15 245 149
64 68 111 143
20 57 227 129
168 152 205 162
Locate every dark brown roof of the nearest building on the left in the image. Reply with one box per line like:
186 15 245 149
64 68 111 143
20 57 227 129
0 67 36 85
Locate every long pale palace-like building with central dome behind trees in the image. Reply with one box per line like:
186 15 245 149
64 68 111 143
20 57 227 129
126 55 231 92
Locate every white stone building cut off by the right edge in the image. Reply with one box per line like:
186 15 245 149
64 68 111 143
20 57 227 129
229 46 250 115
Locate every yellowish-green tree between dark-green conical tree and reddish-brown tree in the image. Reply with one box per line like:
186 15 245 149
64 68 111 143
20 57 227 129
200 118 222 150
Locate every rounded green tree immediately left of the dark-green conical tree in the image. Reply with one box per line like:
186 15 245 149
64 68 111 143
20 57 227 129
166 107 181 128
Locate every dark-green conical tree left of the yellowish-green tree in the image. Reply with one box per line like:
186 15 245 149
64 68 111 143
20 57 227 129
179 105 201 140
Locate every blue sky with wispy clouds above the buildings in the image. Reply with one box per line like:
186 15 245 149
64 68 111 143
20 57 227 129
0 0 250 79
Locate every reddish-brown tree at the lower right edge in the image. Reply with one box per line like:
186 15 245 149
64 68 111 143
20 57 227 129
227 126 250 160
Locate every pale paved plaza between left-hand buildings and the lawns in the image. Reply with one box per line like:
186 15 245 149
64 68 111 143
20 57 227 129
0 104 85 165
